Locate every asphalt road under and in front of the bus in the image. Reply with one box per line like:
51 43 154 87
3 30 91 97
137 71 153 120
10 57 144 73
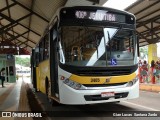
36 91 160 120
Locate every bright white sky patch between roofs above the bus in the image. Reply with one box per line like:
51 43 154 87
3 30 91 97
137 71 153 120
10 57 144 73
103 0 137 10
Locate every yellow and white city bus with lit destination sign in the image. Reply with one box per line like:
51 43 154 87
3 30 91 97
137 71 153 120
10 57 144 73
31 6 139 105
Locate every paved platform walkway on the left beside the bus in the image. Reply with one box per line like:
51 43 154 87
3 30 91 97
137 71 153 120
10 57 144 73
0 79 32 120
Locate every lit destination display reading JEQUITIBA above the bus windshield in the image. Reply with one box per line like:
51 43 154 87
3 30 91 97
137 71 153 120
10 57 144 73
75 10 125 22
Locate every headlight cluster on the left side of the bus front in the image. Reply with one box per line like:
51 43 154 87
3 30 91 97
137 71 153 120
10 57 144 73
63 78 85 90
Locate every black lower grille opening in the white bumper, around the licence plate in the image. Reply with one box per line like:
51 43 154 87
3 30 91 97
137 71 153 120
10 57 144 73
84 92 128 101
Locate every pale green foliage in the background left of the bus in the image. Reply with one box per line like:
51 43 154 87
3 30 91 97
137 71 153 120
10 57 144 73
16 56 30 67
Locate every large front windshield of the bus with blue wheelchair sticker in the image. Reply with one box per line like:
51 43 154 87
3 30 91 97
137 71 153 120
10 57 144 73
59 26 136 67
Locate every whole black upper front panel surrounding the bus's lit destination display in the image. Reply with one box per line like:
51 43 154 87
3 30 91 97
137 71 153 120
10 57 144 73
60 6 135 26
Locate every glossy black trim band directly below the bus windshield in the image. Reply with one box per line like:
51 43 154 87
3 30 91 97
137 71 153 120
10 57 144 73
59 62 138 76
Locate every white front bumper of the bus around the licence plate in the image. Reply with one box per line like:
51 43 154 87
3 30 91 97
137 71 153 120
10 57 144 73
59 81 139 105
